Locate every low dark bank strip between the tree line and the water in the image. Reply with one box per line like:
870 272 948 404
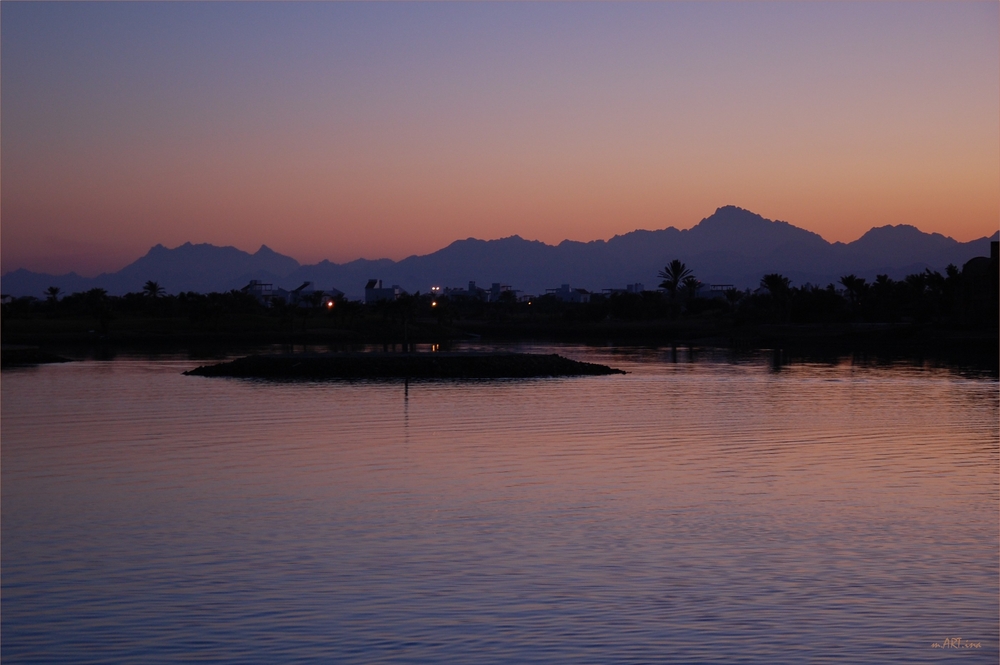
3 318 1000 351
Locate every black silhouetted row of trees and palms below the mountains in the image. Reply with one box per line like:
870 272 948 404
2 257 1000 333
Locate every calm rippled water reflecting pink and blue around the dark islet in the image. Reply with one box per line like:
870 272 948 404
2 347 1000 663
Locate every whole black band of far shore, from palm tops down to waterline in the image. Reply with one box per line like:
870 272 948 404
0 254 1000 365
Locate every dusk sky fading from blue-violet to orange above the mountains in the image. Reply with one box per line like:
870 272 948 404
0 1 1000 276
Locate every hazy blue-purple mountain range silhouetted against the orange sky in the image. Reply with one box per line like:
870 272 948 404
0 206 1000 298
